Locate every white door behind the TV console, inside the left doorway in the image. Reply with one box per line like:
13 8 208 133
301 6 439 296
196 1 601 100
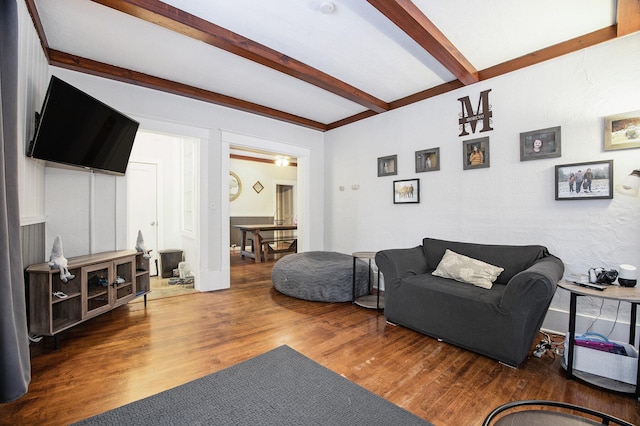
127 162 158 275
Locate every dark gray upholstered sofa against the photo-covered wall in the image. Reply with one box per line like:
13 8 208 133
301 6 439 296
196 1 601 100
376 238 564 367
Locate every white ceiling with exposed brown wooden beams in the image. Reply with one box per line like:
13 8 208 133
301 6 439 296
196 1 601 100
26 0 640 131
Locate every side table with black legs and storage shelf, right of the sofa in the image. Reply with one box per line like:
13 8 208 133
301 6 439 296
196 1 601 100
558 280 640 400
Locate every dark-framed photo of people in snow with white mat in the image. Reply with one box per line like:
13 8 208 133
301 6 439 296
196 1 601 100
555 160 613 200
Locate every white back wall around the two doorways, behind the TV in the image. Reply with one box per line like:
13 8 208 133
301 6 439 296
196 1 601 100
26 67 324 290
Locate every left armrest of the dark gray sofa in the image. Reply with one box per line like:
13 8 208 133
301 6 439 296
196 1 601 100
376 246 427 289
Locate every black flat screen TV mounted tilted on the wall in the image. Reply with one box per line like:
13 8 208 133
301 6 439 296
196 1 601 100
27 76 139 176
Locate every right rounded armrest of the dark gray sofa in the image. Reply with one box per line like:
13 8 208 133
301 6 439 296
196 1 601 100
500 255 564 313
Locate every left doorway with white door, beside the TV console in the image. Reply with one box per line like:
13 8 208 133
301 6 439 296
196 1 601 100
126 130 199 297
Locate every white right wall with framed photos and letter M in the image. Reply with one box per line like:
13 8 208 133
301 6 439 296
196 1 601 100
324 33 640 340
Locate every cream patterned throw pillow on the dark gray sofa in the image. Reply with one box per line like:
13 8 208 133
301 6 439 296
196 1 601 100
432 249 504 289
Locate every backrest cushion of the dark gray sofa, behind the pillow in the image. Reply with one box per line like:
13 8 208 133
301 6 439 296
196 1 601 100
422 238 549 284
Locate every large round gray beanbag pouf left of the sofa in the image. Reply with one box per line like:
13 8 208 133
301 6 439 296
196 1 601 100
271 251 369 302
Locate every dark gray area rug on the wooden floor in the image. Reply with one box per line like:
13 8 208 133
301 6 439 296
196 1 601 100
76 345 430 426
